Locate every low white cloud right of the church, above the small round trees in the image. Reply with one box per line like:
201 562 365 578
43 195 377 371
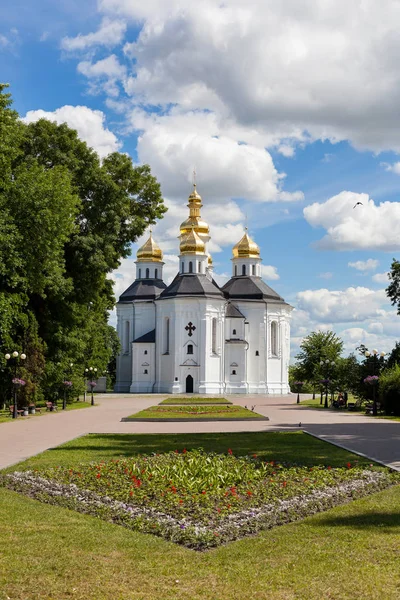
297 287 387 323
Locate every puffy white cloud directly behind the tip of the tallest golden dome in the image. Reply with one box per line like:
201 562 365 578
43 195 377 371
130 110 303 207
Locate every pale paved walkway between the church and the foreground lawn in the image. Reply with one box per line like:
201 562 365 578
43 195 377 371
0 394 400 470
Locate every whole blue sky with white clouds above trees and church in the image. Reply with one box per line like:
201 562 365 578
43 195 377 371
0 0 400 353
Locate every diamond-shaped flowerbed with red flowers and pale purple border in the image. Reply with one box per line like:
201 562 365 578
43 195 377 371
0 449 399 550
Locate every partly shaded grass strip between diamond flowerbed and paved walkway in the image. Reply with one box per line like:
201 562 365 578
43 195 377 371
3 431 370 471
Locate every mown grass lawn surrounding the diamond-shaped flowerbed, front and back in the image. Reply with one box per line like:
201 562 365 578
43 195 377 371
0 432 400 600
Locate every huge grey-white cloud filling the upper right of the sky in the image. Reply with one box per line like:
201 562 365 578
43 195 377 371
99 0 400 152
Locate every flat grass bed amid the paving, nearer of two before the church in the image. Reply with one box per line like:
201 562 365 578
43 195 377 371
127 404 265 420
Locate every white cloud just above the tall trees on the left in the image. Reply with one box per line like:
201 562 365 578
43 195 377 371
23 105 121 157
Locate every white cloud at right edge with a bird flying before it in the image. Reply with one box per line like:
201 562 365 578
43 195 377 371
303 191 400 252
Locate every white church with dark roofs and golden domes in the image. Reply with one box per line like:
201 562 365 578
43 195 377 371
115 185 292 394
